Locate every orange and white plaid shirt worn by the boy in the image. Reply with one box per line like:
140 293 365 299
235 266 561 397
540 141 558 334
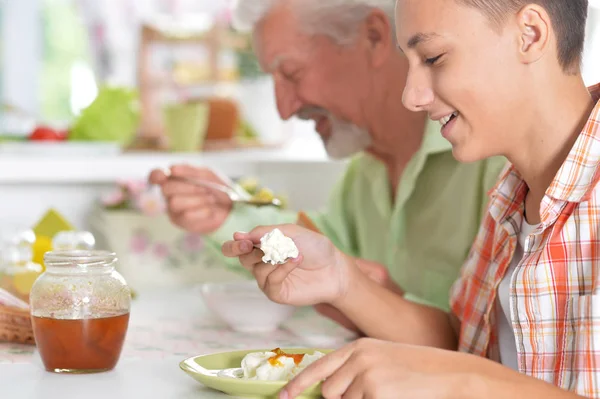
451 85 600 398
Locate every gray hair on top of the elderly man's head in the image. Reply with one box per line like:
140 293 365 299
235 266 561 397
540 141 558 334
233 0 395 45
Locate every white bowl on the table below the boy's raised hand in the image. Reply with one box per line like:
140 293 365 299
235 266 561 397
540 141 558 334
201 280 296 333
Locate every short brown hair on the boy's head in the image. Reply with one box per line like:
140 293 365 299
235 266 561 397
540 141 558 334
457 0 588 73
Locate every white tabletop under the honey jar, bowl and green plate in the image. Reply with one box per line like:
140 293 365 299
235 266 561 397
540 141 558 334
0 290 352 399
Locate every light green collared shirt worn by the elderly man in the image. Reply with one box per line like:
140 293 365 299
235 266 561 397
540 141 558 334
207 122 506 310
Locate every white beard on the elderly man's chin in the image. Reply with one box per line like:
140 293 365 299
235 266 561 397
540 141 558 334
323 115 372 159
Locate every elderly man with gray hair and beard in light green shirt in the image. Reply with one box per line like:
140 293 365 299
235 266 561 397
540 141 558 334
150 0 504 328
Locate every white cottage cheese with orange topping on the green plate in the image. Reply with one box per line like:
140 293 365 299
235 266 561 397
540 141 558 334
242 348 325 381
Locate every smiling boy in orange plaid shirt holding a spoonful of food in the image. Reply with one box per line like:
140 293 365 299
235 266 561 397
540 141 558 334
224 0 600 398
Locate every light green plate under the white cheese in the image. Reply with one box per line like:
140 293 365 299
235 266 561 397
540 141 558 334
179 348 331 399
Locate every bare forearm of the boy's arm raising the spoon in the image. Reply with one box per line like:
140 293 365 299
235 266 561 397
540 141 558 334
333 264 457 350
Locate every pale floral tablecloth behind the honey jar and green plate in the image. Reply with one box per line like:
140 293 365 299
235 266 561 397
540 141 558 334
0 289 354 364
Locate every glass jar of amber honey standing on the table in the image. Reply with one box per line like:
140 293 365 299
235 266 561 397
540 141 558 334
30 250 131 373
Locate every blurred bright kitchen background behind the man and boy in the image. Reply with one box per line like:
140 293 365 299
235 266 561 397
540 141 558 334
0 0 600 290
